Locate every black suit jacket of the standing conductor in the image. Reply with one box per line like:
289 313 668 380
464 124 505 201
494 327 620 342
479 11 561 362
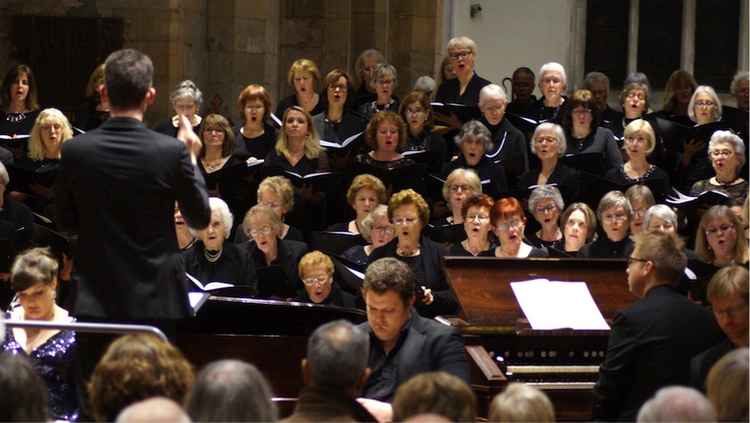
56 117 211 320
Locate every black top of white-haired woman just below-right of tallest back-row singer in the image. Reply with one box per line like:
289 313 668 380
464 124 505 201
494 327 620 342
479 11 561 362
481 118 529 187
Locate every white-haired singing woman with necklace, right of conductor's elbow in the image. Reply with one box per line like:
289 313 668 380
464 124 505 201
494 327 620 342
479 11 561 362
182 197 258 295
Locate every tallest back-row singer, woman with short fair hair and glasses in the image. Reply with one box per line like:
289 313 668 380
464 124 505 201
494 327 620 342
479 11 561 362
435 37 490 106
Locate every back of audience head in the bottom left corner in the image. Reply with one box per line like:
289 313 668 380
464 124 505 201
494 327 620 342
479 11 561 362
0 353 49 422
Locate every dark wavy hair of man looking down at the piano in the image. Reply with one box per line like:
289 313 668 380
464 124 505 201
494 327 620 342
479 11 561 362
362 257 416 305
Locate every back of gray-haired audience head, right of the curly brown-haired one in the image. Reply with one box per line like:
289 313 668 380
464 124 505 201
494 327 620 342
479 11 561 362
185 360 276 422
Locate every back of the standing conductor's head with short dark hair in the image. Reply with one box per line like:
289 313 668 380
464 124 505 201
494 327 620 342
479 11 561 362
104 49 154 109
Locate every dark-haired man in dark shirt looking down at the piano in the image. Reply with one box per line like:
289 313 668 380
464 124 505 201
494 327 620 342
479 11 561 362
361 258 469 401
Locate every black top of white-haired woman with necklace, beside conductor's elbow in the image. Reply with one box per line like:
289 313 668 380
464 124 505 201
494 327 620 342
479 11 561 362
182 241 258 295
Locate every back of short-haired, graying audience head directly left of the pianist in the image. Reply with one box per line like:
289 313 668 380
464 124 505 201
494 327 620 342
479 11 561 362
307 320 370 390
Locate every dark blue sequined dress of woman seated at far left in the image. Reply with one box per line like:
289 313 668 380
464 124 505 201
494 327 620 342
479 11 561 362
3 328 78 421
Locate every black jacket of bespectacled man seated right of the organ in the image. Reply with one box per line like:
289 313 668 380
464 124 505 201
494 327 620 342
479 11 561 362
593 285 723 421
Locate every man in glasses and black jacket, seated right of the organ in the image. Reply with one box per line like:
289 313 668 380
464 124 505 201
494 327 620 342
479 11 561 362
593 232 721 420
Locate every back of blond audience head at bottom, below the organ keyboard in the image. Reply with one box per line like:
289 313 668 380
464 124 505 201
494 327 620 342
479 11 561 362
488 383 555 423
